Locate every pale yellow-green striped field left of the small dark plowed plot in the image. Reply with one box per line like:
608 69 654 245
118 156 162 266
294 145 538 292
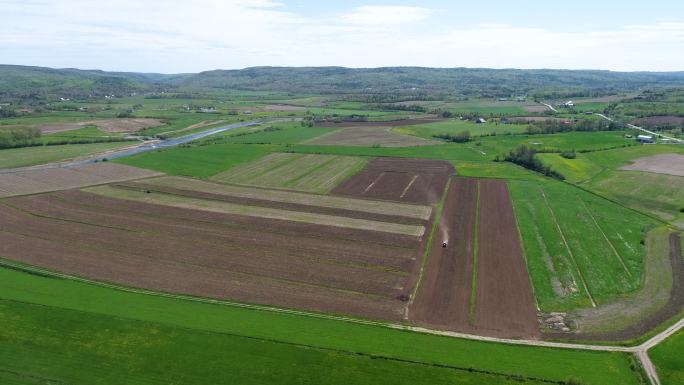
212 153 368 194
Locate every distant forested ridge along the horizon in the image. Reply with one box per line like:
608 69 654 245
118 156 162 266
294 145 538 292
0 65 684 102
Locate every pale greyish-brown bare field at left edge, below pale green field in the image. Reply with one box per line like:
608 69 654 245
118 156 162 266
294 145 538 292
0 163 162 198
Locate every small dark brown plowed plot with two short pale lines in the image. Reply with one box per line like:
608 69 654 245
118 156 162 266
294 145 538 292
332 158 454 204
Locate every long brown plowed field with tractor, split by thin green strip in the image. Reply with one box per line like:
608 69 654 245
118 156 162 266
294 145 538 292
409 177 540 338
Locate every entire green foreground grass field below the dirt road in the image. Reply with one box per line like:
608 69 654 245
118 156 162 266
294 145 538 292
0 268 640 385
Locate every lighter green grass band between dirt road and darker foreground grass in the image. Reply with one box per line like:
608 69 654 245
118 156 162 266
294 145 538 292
0 260 641 385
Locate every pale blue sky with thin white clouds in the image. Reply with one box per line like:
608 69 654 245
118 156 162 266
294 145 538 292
0 0 684 73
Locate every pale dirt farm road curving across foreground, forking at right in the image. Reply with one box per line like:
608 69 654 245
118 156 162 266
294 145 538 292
0 258 684 385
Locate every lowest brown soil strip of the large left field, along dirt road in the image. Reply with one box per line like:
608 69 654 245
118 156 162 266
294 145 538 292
0 230 403 320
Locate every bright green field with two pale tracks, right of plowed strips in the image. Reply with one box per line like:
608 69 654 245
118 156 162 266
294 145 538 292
509 181 657 311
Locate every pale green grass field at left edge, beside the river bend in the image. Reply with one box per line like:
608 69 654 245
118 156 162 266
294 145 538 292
0 142 131 168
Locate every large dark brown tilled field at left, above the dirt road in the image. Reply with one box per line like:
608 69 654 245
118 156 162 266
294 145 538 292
0 190 424 320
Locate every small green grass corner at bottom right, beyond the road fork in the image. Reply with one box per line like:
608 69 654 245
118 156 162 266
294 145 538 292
648 330 684 385
